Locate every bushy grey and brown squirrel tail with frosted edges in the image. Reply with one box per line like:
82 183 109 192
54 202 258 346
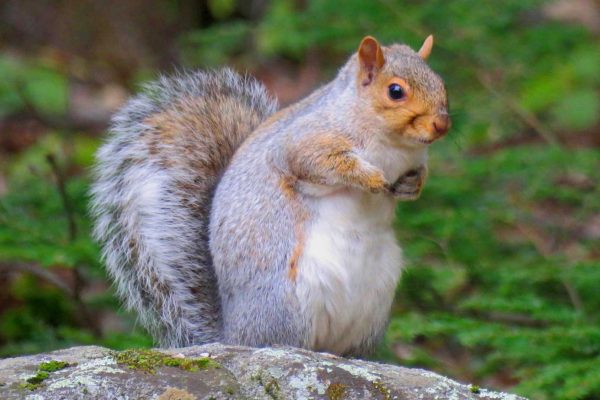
92 69 277 347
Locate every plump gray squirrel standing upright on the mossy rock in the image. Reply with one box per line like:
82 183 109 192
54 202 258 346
92 36 450 356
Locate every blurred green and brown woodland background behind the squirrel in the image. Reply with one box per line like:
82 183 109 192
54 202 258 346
0 0 600 399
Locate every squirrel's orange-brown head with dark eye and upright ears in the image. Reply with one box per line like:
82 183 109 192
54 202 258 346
356 36 450 144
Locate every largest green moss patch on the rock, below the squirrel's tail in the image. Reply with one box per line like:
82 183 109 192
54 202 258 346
114 349 220 374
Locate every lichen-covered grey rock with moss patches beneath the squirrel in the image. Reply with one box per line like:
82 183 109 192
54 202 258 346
0 344 521 400
